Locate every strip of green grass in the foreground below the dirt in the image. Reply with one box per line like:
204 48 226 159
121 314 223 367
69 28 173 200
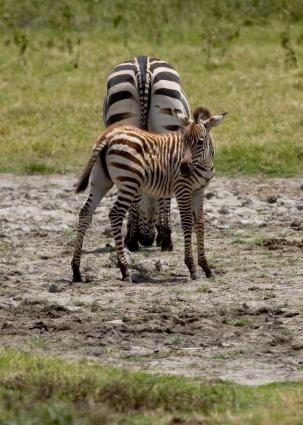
0 349 303 425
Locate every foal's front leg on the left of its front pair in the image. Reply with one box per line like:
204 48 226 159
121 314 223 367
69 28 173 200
176 187 198 280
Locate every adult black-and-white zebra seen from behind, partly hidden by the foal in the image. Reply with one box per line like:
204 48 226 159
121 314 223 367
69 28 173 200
103 56 190 251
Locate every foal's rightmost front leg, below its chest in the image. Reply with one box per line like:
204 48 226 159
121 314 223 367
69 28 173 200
192 189 214 278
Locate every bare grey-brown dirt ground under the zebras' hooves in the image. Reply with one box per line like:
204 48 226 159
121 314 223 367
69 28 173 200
0 174 303 384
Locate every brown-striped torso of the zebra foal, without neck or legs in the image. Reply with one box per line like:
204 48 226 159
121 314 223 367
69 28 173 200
106 126 182 198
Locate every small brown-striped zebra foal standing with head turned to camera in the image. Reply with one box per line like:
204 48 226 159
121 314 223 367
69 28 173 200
71 108 225 282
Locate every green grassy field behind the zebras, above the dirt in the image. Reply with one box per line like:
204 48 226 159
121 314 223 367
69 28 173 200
0 0 303 176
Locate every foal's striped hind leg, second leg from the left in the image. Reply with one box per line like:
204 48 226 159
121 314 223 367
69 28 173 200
109 191 134 283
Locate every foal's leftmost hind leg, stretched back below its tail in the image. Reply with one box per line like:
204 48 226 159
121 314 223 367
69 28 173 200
71 160 113 282
